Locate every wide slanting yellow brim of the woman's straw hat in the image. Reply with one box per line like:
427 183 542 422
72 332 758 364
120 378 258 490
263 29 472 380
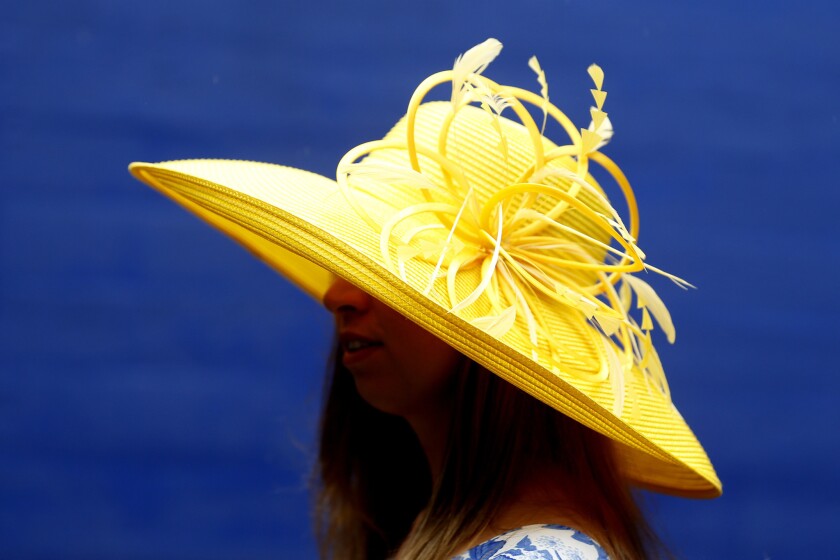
129 160 721 498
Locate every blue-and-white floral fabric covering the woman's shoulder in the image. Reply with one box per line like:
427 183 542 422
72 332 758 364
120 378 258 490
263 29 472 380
452 524 609 560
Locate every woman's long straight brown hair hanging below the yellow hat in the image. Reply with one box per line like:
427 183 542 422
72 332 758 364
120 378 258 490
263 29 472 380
314 349 661 560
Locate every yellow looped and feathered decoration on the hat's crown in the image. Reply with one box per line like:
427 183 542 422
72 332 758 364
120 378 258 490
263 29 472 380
338 39 689 416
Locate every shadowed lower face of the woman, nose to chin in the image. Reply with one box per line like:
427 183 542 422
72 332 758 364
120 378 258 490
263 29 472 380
324 279 463 418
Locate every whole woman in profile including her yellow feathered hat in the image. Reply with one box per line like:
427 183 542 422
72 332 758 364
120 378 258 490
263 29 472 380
130 39 721 559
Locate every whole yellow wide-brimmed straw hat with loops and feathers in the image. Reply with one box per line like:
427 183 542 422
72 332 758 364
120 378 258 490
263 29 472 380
130 39 721 497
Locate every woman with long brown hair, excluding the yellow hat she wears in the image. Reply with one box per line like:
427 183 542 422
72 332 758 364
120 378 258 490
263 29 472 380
319 280 656 558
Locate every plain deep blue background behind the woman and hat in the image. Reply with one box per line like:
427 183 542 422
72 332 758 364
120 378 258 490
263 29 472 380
0 0 840 559
